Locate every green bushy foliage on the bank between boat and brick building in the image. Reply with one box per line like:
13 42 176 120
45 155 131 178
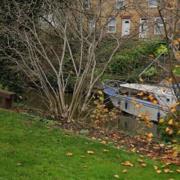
109 41 164 80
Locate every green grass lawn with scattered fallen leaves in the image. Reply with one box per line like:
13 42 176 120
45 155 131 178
0 110 180 180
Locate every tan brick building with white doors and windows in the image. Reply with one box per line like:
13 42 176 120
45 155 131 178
83 0 180 38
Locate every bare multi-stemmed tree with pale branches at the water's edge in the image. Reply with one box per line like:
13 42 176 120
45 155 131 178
1 0 134 121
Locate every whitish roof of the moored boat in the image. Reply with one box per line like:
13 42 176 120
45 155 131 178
120 83 174 96
